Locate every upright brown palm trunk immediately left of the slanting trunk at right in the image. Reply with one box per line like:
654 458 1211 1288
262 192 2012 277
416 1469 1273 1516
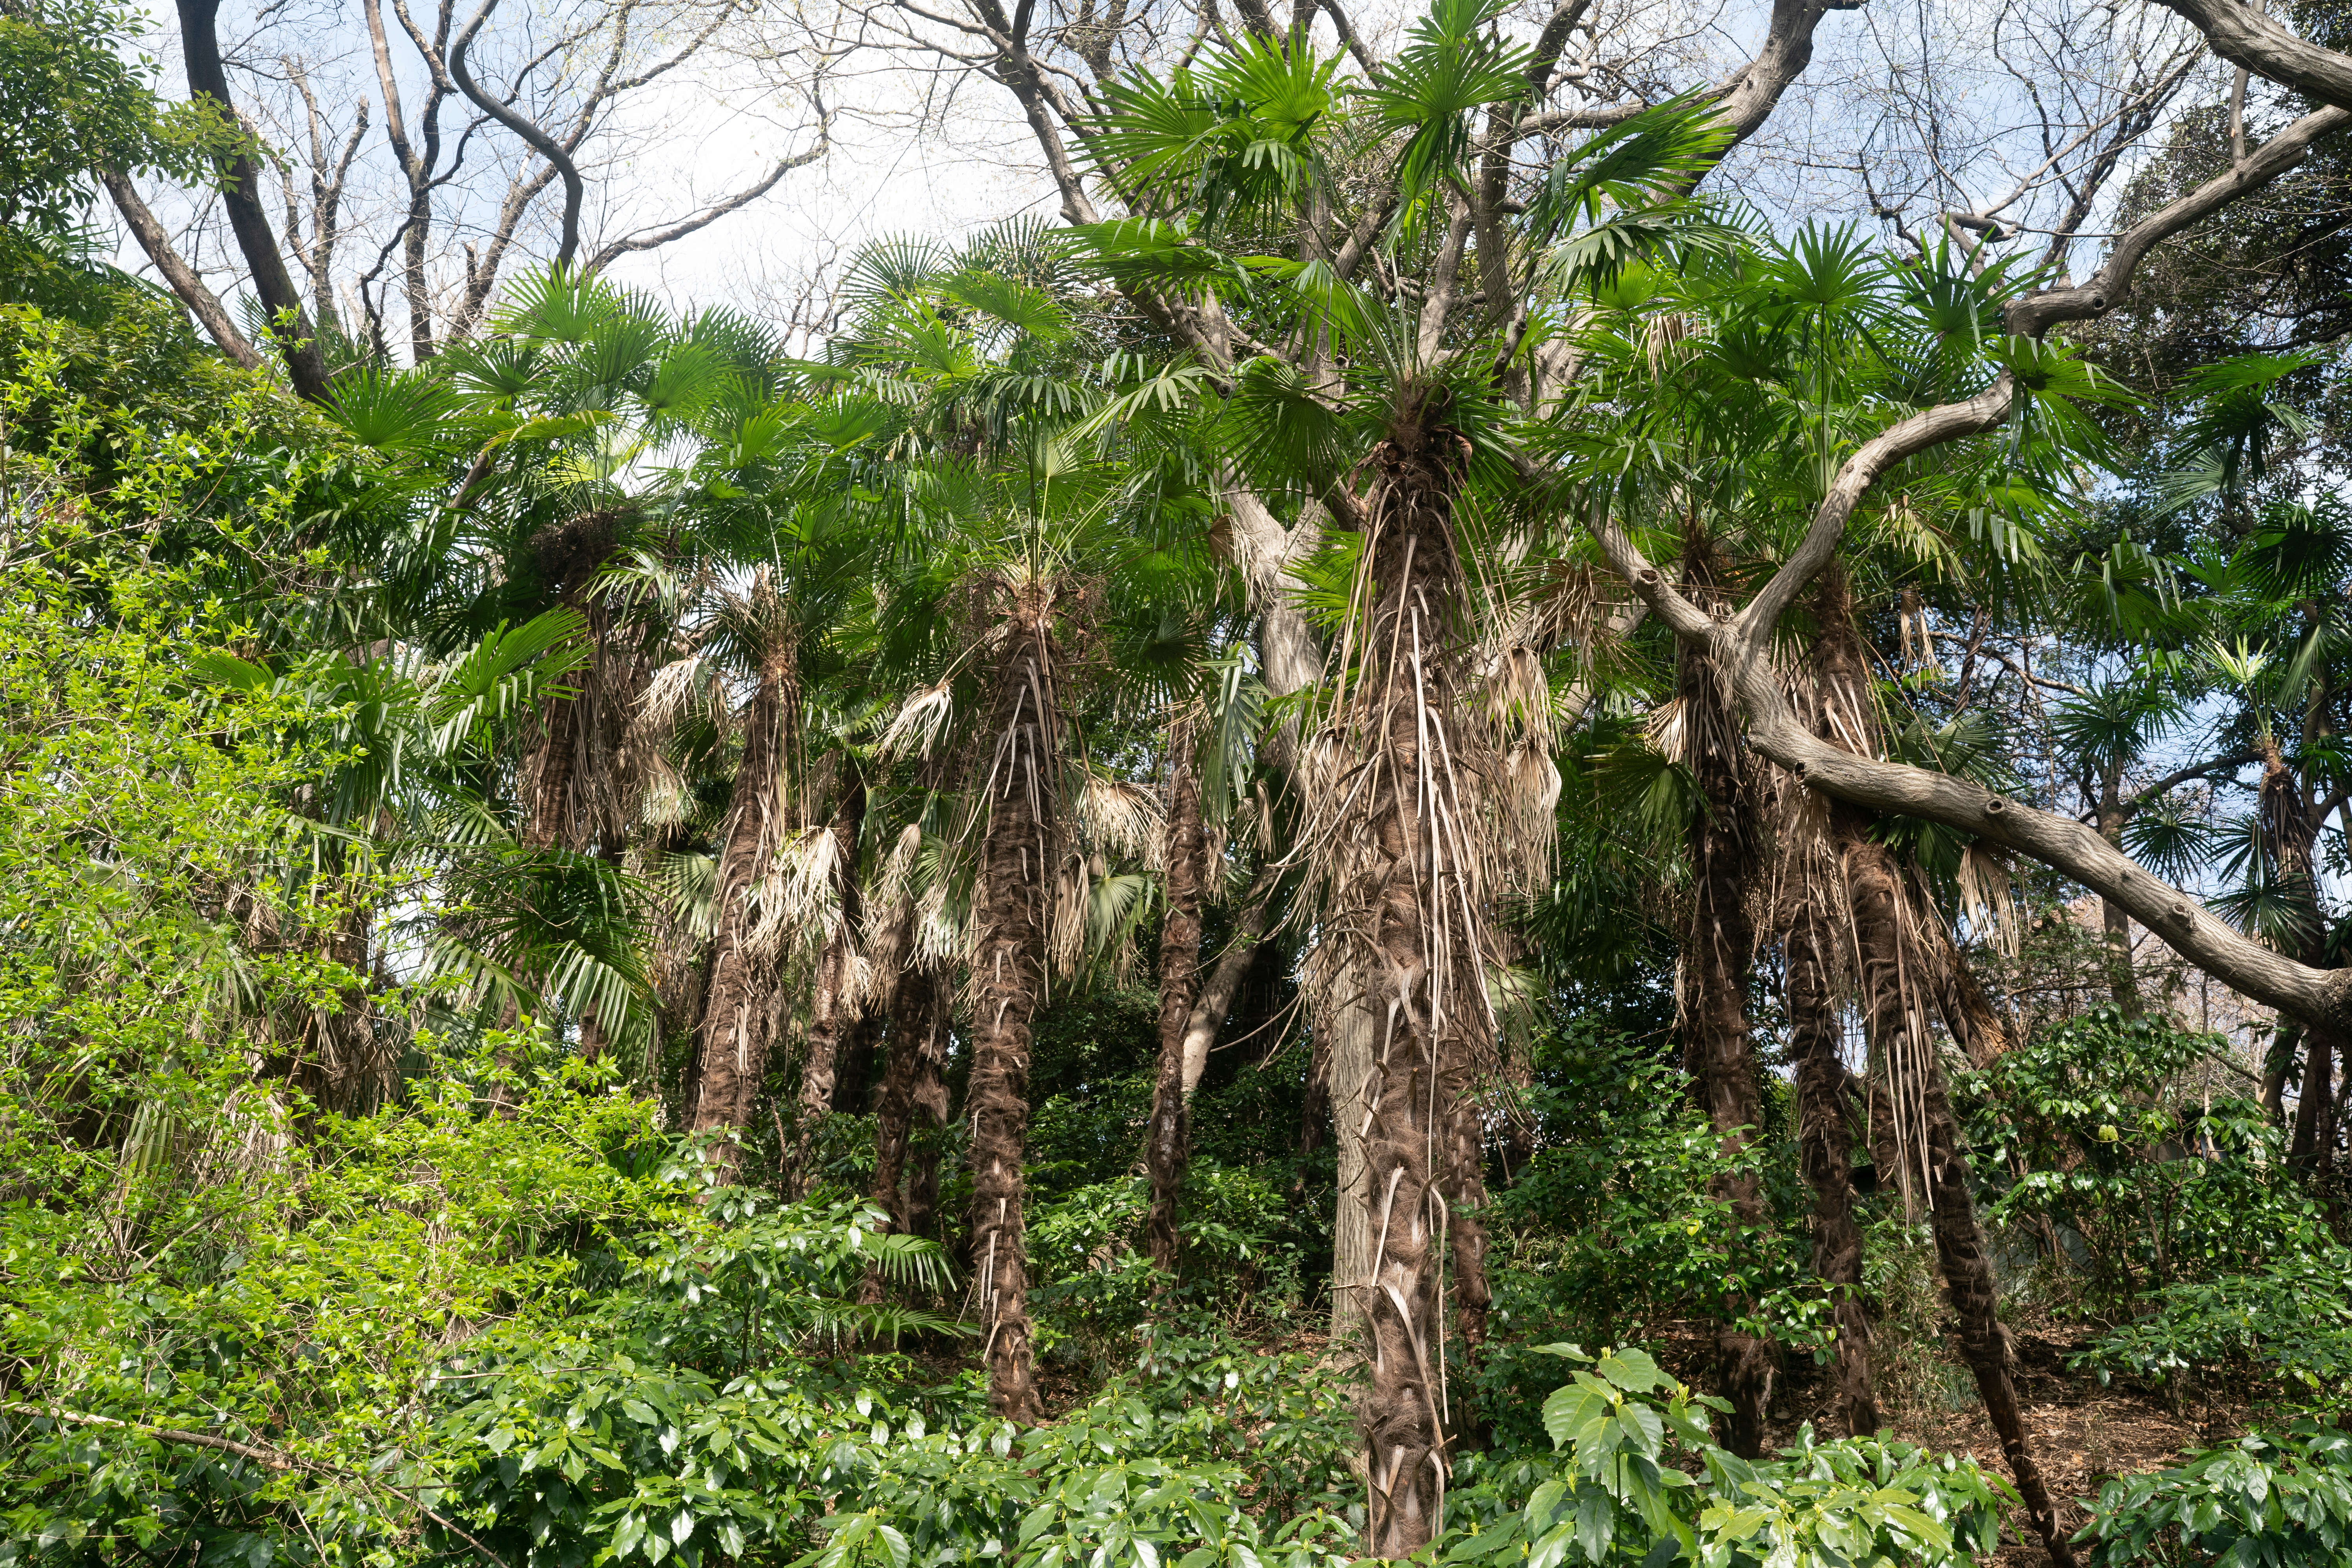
1783 867 1879 1436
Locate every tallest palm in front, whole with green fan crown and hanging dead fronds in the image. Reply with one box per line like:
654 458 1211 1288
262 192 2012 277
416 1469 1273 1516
1080 27 1726 1556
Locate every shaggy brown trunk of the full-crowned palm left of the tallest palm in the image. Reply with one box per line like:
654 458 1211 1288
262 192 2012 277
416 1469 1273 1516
967 588 1061 1425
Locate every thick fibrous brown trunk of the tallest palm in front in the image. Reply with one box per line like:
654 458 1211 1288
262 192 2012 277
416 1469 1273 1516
1343 407 1494 1559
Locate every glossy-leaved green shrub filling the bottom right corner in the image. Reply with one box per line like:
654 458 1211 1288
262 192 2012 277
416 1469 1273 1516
2074 1422 2352 1568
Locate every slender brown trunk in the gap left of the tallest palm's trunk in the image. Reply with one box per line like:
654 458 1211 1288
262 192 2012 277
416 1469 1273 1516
1143 722 1209 1274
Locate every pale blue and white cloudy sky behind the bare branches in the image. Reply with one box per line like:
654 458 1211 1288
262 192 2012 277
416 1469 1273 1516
101 0 2239 350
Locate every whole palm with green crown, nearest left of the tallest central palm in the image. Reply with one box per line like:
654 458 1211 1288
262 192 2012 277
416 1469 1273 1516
840 270 1148 1422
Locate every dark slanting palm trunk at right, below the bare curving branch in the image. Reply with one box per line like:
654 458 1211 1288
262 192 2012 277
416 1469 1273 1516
1846 835 2074 1568
